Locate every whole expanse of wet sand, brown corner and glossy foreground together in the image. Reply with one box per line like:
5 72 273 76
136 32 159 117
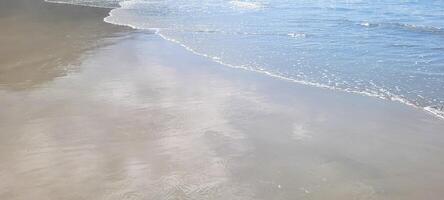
0 2 444 200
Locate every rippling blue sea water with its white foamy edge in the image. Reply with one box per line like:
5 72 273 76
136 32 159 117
48 0 444 117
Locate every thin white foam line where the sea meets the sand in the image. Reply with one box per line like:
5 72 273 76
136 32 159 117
80 1 444 119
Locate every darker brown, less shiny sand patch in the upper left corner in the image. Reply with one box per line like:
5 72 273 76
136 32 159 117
0 0 129 89
